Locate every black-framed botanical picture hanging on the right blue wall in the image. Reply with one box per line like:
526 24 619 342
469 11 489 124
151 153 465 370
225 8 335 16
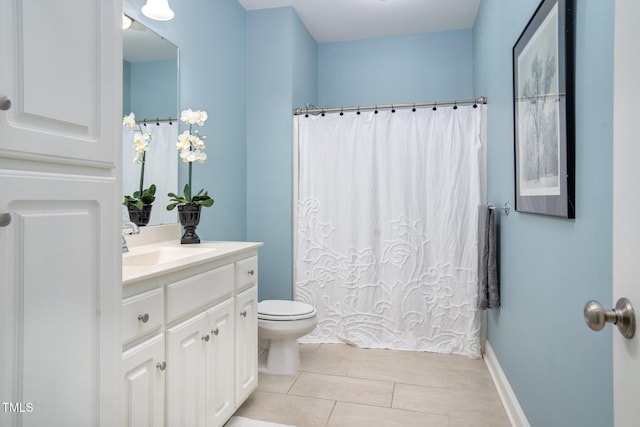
513 0 575 218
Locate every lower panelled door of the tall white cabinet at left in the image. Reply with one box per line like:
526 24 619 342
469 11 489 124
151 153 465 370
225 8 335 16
0 169 122 427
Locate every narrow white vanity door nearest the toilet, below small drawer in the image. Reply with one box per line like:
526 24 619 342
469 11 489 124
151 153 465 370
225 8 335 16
235 286 258 407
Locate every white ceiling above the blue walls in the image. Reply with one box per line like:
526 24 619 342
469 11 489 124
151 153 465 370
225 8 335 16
238 0 481 43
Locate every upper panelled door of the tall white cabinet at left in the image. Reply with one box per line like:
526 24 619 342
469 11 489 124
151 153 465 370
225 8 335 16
0 0 122 168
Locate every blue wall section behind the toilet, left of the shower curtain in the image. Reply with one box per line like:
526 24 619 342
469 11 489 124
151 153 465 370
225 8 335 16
247 7 316 300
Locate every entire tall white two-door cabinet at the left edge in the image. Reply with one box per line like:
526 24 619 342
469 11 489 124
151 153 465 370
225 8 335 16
0 0 122 427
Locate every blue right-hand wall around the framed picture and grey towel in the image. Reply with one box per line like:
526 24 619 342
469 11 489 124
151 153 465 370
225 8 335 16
474 0 613 427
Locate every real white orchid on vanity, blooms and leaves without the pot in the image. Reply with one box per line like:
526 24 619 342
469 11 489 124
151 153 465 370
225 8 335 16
167 109 213 211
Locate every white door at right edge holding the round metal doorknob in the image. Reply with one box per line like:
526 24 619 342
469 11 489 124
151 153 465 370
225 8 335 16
613 0 640 427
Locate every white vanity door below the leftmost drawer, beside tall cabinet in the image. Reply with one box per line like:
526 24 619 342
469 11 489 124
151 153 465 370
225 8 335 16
121 334 166 427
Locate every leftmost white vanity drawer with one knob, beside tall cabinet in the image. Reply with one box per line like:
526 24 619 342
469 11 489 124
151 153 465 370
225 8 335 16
122 288 164 342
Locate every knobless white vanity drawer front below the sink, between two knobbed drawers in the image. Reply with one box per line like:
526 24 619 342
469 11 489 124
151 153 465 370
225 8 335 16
167 264 234 322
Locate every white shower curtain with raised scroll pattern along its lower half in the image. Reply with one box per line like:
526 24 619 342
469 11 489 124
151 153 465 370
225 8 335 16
294 106 484 357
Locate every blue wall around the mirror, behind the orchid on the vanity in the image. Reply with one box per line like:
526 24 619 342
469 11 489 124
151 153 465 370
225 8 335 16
123 0 247 240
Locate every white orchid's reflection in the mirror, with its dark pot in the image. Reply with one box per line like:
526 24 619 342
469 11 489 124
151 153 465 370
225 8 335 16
122 113 156 226
